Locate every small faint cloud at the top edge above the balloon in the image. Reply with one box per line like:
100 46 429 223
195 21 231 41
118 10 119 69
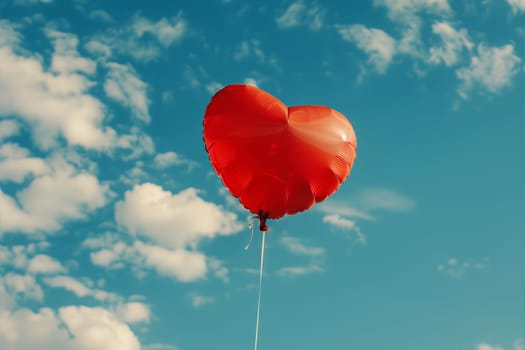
275 0 325 31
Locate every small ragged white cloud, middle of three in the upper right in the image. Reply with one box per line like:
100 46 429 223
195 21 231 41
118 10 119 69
429 22 474 66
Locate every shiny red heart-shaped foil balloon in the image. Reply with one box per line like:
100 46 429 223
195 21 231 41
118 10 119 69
204 85 357 223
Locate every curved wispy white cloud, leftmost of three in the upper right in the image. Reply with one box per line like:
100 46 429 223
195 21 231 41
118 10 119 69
337 24 396 73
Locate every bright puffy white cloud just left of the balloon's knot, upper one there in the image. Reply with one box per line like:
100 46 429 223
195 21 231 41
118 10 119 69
115 183 242 248
